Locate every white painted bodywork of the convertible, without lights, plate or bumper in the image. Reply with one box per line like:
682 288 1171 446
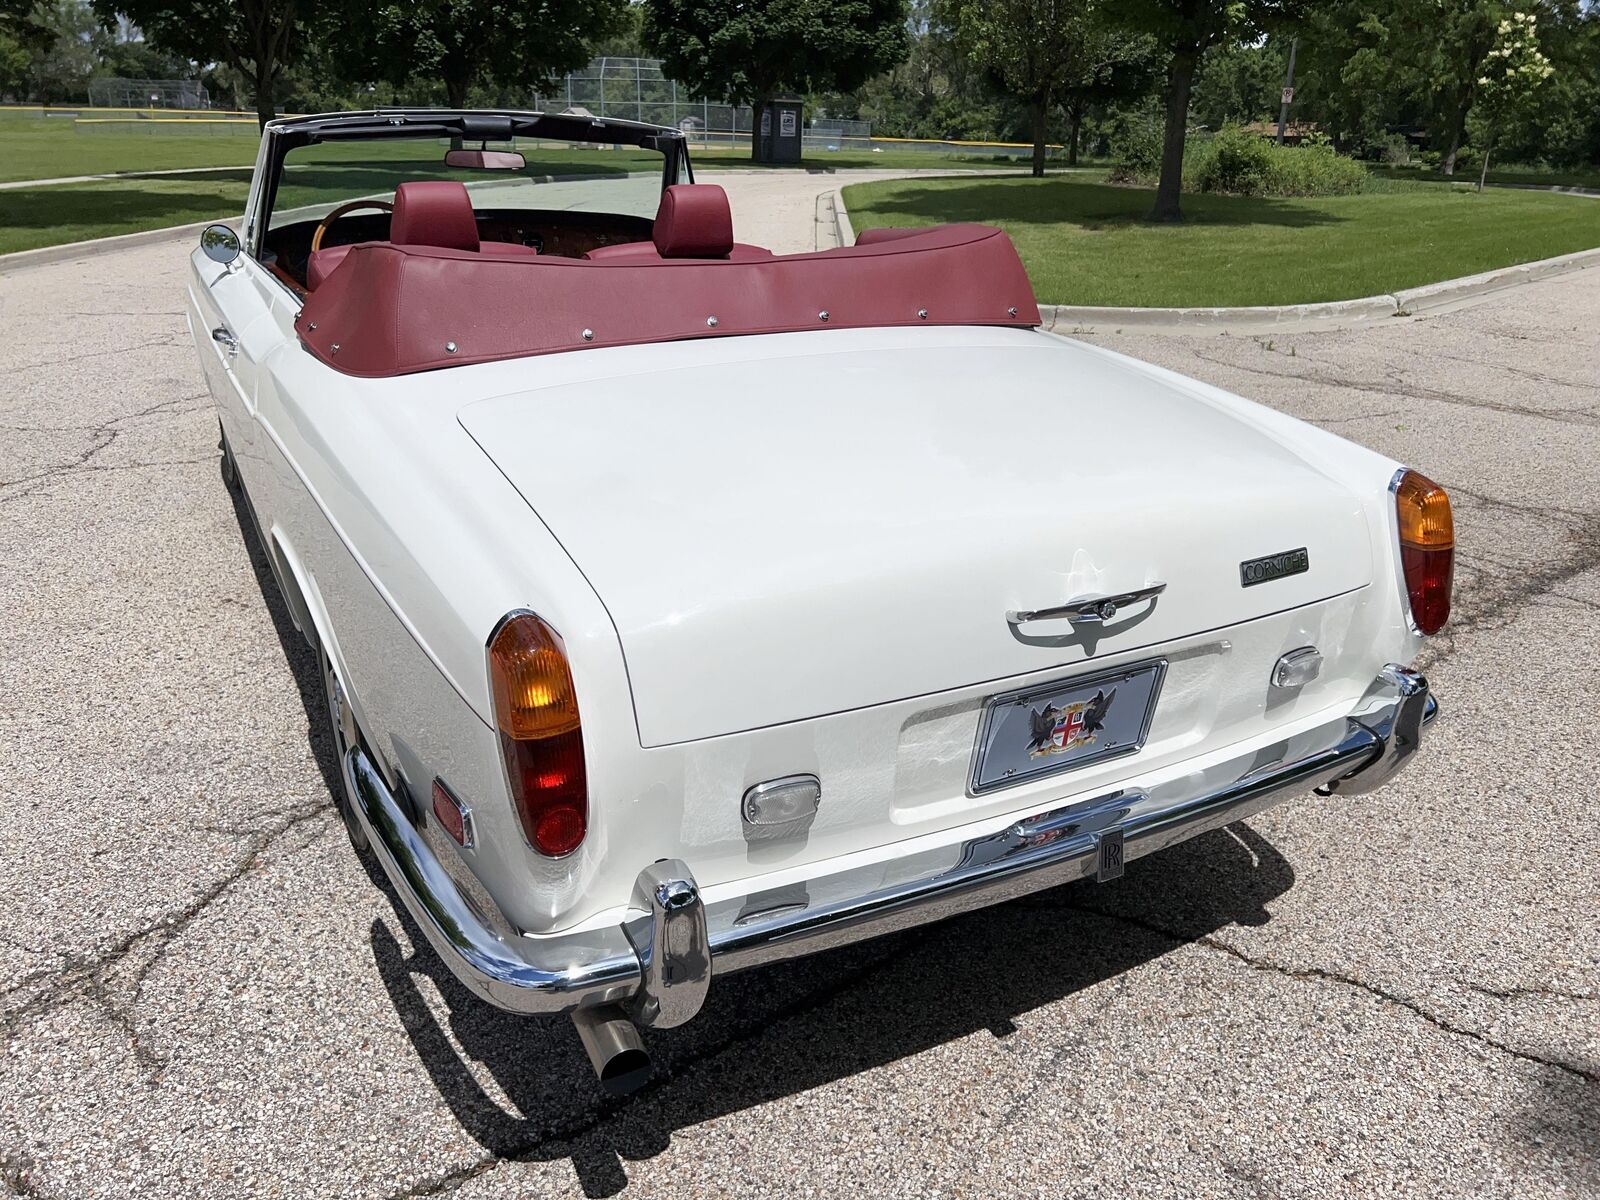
189 115 1421 938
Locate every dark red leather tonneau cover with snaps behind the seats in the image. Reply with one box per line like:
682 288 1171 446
294 226 1038 378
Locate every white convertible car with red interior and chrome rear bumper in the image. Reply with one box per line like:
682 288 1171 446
189 110 1453 1090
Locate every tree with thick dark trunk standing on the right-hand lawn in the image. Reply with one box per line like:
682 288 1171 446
1117 0 1306 221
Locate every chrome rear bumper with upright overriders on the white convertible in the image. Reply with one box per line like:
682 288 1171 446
344 664 1438 1027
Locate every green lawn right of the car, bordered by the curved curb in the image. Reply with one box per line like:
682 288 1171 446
845 178 1600 307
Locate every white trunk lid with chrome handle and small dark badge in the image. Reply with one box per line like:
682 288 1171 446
461 328 1386 746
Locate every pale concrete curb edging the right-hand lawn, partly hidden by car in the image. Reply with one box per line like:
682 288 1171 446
834 187 1600 333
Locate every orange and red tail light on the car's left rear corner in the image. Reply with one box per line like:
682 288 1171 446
490 613 589 858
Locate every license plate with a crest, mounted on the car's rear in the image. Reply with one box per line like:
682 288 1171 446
971 659 1166 795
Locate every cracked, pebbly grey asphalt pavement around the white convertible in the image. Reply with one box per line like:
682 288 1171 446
0 227 1600 1198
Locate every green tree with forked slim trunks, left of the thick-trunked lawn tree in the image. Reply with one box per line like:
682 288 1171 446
949 0 1142 176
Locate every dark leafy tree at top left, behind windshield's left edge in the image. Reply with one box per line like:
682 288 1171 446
93 0 304 125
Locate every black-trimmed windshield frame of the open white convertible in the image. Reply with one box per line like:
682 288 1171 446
245 109 694 261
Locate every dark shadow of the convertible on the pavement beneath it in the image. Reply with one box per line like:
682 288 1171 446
232 454 1294 1197
